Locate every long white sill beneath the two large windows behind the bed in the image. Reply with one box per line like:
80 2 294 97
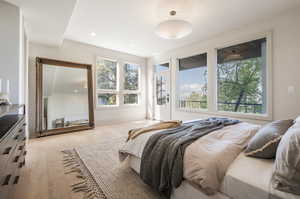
176 108 273 121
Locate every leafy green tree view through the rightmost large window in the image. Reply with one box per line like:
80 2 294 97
218 57 263 113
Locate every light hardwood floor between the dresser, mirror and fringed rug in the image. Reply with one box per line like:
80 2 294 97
14 120 153 199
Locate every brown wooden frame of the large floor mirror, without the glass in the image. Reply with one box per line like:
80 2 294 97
36 57 95 137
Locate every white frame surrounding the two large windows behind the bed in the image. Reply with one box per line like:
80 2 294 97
173 31 273 121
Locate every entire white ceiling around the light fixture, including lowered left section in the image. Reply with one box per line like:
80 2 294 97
10 0 300 57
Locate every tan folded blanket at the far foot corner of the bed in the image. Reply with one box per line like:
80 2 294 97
127 120 182 142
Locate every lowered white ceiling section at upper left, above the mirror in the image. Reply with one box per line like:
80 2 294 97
6 0 76 46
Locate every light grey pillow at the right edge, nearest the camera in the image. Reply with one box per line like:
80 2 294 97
272 122 300 195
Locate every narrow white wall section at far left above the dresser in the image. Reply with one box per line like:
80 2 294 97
0 0 23 104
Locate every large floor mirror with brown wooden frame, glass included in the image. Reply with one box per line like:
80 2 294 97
36 58 94 136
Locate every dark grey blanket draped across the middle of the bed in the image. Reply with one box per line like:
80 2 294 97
140 118 239 196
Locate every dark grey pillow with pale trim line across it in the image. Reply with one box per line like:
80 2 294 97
245 120 293 159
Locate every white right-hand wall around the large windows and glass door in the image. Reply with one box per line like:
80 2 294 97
147 8 300 122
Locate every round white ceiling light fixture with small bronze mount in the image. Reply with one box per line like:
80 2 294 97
155 10 192 39
